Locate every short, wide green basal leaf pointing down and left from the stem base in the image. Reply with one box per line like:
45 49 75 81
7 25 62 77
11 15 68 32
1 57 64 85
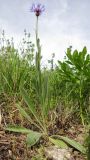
26 132 42 147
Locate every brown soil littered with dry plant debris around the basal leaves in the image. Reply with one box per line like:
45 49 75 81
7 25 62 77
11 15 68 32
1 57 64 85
0 103 86 160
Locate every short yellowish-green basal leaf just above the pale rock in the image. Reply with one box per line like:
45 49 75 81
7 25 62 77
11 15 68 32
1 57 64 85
49 137 68 149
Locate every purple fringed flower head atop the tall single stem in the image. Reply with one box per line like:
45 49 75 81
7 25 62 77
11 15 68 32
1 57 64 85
31 4 45 17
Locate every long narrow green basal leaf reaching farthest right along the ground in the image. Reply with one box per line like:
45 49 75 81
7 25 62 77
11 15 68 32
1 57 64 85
52 135 86 154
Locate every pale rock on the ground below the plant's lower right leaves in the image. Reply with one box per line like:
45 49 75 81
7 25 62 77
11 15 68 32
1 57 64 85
45 146 70 160
